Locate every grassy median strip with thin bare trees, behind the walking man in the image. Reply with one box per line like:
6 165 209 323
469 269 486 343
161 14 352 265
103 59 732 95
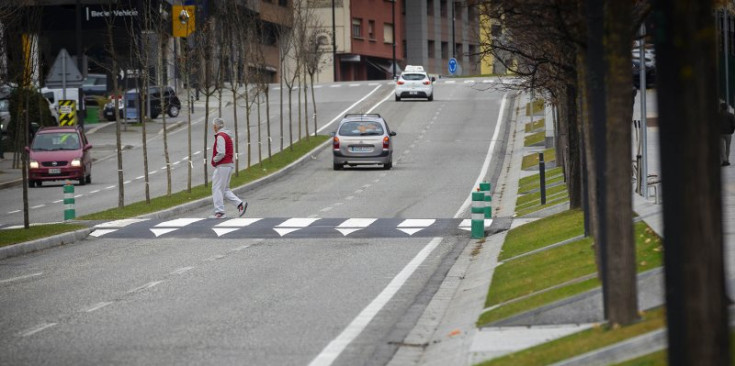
78 135 329 220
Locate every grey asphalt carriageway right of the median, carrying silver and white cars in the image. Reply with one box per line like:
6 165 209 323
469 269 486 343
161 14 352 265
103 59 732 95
0 78 507 365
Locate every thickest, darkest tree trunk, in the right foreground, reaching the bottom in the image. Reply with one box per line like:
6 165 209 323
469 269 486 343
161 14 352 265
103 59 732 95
653 0 731 365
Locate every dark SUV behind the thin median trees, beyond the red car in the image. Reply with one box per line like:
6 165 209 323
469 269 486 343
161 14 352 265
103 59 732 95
103 86 181 121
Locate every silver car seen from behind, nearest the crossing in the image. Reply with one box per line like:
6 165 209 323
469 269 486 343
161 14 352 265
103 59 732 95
332 114 396 170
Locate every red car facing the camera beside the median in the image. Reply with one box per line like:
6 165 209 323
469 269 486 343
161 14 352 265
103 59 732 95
26 126 92 187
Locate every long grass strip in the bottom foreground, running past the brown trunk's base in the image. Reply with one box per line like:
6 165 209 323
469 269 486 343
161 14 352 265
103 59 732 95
479 308 666 366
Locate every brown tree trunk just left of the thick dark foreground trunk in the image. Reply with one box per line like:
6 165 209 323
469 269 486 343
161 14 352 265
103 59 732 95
598 0 638 324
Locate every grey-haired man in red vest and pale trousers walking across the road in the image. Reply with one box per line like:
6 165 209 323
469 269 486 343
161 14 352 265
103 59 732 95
212 118 248 219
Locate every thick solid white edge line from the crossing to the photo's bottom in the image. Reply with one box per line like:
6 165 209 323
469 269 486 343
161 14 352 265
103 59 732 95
309 238 442 366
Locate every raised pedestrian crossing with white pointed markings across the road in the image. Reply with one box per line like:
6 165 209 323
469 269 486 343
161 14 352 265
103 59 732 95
90 217 492 239
